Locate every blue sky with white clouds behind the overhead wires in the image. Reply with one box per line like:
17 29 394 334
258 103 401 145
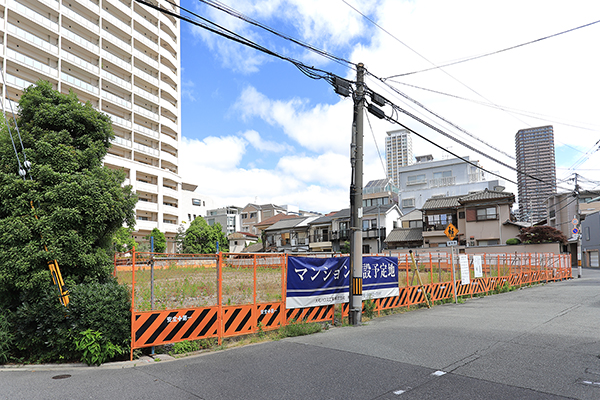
179 0 600 213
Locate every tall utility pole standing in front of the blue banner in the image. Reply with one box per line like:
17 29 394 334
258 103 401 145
348 63 365 326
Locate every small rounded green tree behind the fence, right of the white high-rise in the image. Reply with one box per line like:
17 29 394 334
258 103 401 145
182 217 229 254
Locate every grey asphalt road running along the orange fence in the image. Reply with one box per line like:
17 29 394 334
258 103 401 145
0 269 600 400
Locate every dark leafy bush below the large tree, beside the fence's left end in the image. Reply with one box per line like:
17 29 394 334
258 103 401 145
11 280 131 362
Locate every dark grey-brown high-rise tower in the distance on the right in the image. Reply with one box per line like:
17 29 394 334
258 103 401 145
515 126 556 223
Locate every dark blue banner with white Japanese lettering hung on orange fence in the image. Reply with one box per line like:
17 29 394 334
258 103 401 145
286 257 399 309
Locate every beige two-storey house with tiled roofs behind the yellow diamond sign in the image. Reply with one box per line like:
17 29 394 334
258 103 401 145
422 189 519 247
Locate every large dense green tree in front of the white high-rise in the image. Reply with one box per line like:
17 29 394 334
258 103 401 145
0 81 137 310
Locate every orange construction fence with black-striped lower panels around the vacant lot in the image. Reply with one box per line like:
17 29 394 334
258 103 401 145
114 252 571 357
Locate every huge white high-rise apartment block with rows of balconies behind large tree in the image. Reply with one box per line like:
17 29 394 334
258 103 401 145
0 0 183 247
